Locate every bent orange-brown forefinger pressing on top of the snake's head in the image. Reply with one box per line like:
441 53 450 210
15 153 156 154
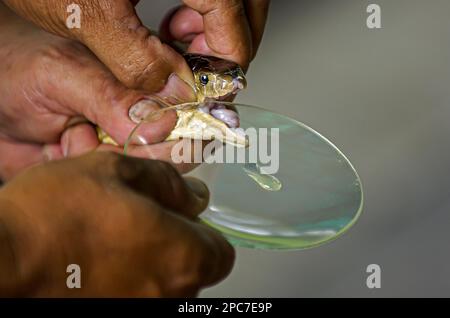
183 0 253 68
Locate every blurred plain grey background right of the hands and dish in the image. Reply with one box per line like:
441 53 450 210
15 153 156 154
138 0 450 297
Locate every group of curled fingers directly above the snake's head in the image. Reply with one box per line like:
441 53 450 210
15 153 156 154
160 0 270 69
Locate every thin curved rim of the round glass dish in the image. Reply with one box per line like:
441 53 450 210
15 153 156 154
124 101 364 251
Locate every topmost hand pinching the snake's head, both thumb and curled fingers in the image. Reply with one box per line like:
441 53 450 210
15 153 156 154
4 0 269 83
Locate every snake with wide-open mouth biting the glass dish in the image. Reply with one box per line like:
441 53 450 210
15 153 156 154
97 53 247 146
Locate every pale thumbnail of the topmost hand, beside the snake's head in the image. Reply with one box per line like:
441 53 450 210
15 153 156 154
157 73 196 104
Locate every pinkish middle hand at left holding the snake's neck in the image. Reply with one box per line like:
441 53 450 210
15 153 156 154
0 3 195 180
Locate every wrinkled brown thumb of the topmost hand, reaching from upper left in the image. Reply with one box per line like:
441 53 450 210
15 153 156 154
6 0 197 92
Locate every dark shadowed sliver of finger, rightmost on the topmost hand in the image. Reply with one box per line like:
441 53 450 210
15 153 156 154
244 0 270 58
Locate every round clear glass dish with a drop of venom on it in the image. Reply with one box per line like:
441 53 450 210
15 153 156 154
125 102 363 250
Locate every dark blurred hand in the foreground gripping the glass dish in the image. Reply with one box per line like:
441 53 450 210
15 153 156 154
0 152 234 296
